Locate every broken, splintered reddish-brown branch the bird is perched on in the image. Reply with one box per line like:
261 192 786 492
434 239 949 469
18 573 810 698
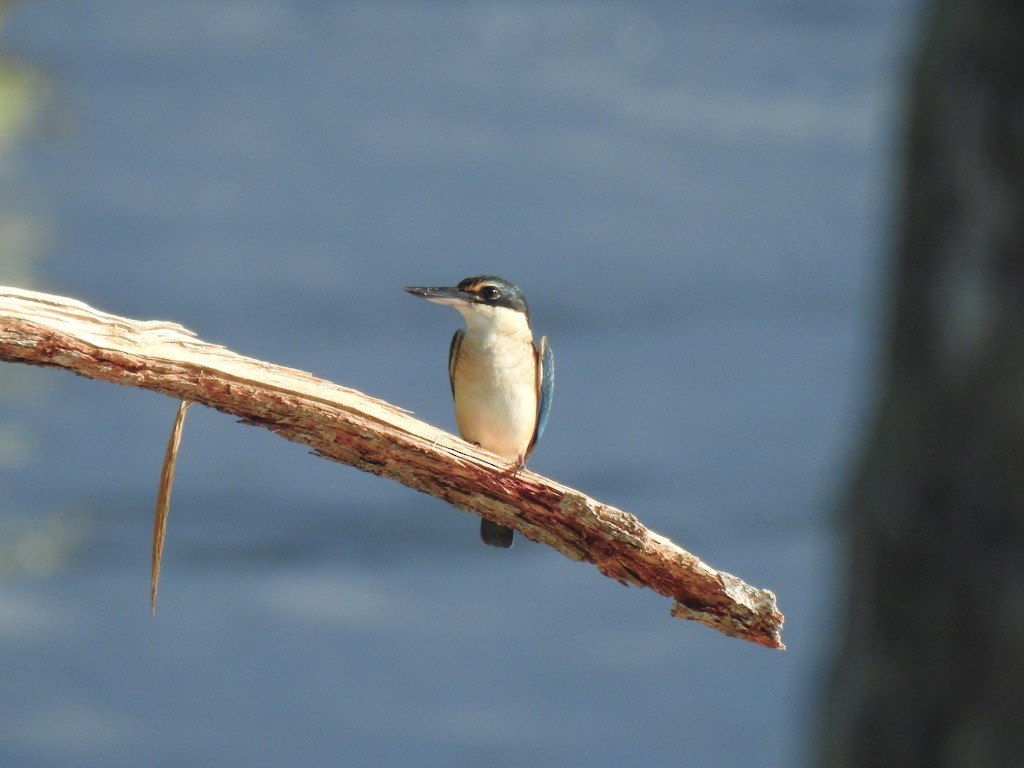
0 287 784 648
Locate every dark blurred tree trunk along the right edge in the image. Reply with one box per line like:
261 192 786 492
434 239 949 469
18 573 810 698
819 0 1024 768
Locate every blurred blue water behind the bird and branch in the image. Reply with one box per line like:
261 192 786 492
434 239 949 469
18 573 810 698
0 0 915 768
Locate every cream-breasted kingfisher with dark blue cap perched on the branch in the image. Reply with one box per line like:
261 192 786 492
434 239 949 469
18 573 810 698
406 274 555 549
